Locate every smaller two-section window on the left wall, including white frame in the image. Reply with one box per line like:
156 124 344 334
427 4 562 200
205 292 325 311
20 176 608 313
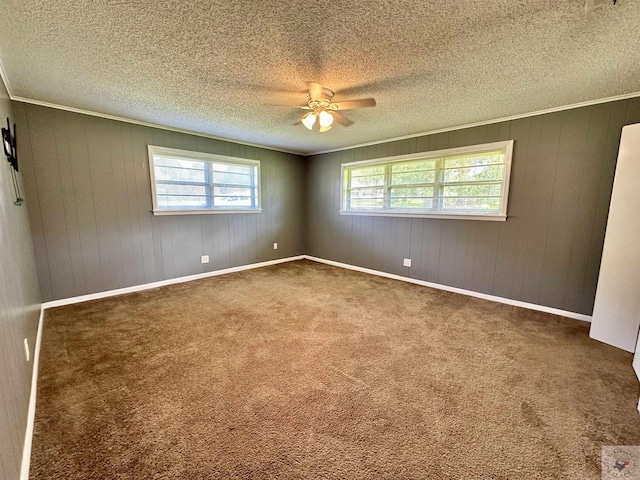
148 145 262 215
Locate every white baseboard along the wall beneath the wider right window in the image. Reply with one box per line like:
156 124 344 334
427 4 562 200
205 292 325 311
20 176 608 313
304 255 591 322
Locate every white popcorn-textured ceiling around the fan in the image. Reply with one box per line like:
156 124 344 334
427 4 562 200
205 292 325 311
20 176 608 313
0 0 640 153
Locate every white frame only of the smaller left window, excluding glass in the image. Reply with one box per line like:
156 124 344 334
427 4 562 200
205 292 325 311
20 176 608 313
147 145 262 215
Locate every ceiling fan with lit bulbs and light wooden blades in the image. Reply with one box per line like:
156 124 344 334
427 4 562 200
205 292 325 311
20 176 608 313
280 82 376 132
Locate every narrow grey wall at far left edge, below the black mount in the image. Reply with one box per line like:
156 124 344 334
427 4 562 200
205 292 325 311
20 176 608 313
0 81 40 480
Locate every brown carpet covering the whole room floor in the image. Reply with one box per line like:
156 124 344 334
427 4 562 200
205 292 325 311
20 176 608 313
31 261 640 480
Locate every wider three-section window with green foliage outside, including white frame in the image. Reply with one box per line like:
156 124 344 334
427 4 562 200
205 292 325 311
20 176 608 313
340 140 513 220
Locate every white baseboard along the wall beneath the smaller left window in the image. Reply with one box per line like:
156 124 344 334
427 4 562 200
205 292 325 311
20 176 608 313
42 255 305 309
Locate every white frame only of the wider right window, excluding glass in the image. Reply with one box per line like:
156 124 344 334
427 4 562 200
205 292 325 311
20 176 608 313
339 140 513 221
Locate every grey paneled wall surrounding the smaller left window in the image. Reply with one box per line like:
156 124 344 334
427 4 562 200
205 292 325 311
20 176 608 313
14 102 305 300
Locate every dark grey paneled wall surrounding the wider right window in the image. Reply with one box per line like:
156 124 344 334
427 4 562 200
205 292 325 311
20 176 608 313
307 98 640 314
